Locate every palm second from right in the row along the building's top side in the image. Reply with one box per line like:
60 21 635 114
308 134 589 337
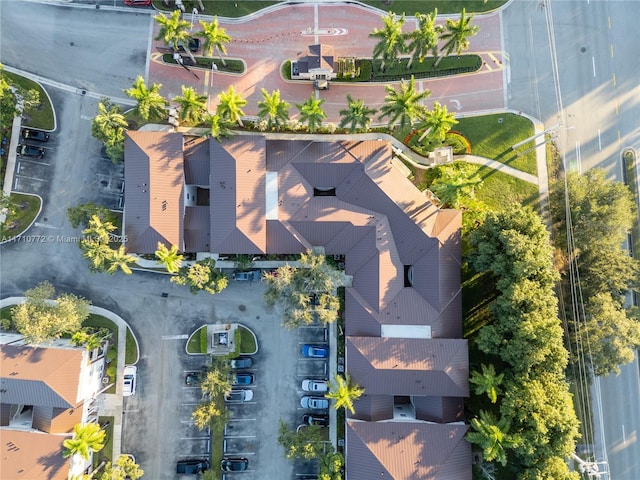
379 75 431 129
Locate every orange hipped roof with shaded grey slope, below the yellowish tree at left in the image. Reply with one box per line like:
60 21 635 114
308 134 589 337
0 345 83 409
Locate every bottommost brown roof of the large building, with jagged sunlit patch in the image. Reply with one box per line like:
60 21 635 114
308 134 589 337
346 420 471 480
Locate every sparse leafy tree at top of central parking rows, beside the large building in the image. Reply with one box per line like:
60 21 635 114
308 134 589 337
264 251 343 328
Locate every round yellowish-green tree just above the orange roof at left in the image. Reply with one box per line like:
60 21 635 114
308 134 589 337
11 281 89 344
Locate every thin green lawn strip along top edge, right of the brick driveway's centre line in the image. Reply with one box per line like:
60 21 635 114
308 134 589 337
362 0 507 15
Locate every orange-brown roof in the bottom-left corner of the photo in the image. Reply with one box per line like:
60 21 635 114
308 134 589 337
0 428 69 480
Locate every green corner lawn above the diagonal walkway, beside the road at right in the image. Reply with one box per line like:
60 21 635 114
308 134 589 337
453 113 538 175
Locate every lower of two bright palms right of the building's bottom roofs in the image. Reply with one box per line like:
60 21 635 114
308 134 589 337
467 410 520 467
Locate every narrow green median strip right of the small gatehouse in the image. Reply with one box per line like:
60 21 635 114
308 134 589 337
371 54 482 82
